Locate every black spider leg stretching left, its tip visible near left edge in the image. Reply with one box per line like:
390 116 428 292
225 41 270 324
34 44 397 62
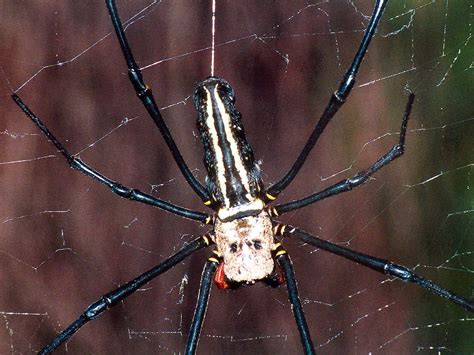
12 94 212 223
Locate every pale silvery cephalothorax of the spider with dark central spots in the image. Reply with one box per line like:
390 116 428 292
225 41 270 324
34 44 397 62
214 211 275 283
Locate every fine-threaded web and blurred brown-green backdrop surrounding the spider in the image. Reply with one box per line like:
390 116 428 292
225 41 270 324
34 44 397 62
0 0 474 354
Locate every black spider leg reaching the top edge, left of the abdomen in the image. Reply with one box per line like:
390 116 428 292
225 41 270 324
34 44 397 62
106 0 209 204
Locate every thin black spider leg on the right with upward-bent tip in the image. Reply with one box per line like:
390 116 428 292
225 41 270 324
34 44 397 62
270 93 415 216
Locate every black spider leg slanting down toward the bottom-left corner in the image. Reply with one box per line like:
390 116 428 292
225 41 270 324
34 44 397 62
38 236 211 354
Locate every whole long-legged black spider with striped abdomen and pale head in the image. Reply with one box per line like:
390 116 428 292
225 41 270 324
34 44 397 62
12 0 474 354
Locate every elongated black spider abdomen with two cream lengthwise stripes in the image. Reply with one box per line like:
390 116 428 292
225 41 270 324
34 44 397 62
193 77 264 221
